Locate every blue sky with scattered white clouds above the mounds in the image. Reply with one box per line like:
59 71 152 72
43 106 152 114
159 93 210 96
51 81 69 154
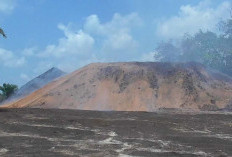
0 0 232 85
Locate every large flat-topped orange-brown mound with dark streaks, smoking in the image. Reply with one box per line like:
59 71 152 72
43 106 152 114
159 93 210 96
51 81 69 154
3 62 232 111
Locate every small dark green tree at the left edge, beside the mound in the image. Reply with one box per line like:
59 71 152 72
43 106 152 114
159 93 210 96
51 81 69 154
0 83 18 98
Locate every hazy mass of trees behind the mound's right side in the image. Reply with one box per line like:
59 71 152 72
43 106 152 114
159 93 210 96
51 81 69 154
155 17 232 76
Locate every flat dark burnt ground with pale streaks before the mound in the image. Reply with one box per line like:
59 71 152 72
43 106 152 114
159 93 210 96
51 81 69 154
0 109 232 157
